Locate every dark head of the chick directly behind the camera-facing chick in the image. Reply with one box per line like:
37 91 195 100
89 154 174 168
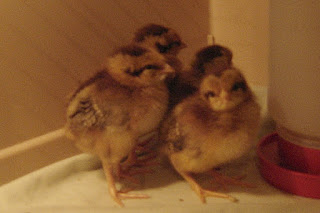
191 45 232 76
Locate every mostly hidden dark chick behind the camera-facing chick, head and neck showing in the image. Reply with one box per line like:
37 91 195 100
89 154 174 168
182 45 232 88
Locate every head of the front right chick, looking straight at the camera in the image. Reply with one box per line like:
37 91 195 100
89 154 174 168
199 69 252 112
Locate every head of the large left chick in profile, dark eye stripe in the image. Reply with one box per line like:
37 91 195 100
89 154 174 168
106 45 175 87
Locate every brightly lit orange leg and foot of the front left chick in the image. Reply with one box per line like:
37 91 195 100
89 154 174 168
102 162 150 207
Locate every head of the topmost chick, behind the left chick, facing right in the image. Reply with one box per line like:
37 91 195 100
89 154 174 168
134 24 187 55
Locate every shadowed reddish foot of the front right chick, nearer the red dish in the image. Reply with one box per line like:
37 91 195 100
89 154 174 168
209 170 256 190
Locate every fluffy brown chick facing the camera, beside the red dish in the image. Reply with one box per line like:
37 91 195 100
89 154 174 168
160 68 260 203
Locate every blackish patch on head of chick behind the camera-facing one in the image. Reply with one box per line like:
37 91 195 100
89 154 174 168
192 45 226 73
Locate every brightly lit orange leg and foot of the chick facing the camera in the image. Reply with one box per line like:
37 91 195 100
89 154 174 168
176 169 237 203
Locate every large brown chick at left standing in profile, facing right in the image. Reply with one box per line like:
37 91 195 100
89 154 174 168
66 45 173 206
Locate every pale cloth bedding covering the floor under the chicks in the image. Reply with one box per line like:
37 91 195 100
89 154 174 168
0 88 320 213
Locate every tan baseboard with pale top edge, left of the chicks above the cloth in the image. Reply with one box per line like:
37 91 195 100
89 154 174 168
0 129 80 185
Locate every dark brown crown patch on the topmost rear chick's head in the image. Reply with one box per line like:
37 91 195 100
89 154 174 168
134 24 169 42
